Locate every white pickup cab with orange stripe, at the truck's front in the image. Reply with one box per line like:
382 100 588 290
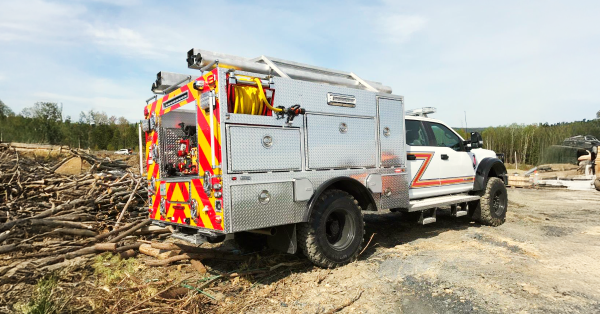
405 115 508 226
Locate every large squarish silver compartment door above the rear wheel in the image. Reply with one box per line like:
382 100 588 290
306 114 377 169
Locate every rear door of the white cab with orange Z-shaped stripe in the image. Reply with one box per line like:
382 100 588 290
405 119 440 199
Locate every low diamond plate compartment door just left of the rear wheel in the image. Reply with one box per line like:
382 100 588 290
230 181 306 232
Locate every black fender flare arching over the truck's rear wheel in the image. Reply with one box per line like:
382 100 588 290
303 177 377 221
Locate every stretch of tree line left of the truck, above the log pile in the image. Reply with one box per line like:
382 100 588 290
0 100 138 150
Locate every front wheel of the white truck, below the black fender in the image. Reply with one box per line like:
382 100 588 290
469 177 508 227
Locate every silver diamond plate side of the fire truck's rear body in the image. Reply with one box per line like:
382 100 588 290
210 68 408 233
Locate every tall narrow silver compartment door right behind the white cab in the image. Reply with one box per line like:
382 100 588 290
379 98 406 167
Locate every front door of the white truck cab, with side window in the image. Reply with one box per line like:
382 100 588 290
424 122 475 195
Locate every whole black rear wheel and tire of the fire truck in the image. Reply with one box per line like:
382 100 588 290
297 190 365 268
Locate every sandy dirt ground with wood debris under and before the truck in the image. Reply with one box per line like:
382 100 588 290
0 189 600 314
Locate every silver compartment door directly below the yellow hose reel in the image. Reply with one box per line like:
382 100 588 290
227 126 302 173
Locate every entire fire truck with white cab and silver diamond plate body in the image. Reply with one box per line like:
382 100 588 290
142 49 508 267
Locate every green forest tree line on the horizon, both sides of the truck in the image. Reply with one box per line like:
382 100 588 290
0 100 600 165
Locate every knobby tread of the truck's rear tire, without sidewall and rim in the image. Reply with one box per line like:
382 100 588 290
297 189 365 268
